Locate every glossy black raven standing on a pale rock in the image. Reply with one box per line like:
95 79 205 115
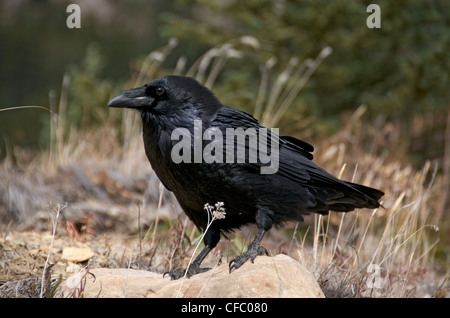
108 76 384 279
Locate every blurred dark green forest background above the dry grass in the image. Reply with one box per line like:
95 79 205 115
0 0 450 166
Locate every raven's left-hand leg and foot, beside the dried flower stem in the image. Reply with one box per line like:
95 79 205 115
163 228 220 280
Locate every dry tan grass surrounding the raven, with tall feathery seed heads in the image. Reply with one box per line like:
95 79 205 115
0 39 448 297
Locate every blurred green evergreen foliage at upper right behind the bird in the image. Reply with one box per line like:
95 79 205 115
160 0 450 129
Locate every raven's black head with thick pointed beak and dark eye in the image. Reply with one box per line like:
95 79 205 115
108 75 221 119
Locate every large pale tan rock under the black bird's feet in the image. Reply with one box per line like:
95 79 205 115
64 254 325 298
